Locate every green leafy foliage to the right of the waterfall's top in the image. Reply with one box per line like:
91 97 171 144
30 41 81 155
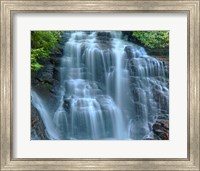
132 31 169 49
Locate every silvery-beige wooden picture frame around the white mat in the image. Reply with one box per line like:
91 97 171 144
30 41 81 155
0 0 200 171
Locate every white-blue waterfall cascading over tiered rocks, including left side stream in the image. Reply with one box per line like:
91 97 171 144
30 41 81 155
32 31 168 140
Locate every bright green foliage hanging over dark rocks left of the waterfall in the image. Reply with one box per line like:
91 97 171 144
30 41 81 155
31 31 62 71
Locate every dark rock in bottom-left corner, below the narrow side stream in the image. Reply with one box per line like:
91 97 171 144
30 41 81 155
31 104 48 140
